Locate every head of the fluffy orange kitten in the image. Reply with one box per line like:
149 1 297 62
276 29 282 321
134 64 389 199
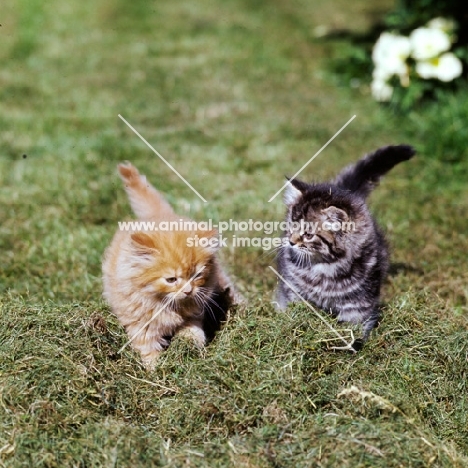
128 232 214 304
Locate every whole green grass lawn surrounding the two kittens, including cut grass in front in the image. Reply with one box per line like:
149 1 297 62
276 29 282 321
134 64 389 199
0 0 468 467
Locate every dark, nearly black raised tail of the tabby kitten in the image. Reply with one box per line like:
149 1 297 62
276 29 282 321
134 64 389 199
334 145 416 198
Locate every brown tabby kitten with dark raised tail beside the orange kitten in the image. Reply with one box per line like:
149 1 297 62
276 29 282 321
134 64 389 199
277 145 415 349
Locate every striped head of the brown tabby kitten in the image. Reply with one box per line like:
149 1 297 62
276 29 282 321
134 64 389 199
285 184 353 263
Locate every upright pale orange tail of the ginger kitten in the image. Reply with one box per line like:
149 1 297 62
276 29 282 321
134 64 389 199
118 162 174 219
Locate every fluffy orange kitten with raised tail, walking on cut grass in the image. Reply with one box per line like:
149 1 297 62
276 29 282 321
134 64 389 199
102 163 234 368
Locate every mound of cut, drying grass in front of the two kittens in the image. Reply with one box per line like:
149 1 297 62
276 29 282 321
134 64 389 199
0 293 468 468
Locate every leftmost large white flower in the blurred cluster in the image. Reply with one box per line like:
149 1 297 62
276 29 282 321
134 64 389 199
372 32 411 76
